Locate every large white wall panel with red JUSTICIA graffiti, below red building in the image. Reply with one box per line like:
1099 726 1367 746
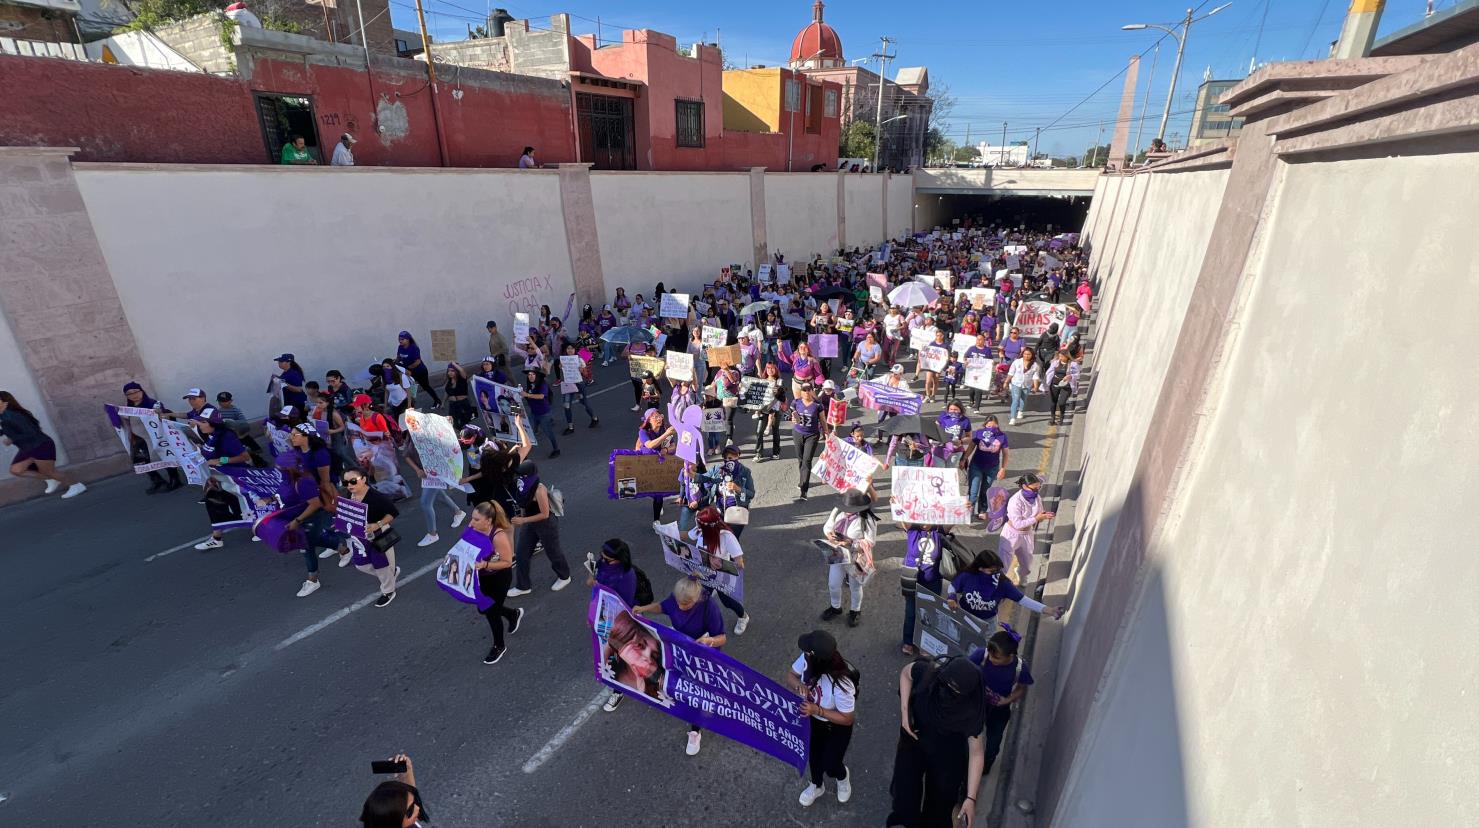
77 164 574 415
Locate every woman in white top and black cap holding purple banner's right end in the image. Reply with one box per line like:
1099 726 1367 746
785 630 859 807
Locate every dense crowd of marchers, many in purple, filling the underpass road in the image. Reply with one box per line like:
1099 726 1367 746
0 212 1093 827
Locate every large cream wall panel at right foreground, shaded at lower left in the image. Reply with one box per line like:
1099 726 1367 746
1057 154 1479 828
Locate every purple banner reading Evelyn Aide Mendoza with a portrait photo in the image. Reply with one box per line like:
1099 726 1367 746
587 584 812 773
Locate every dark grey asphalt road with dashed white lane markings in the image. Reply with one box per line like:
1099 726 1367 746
0 357 1057 828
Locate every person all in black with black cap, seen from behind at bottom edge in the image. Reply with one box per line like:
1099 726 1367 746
886 655 986 828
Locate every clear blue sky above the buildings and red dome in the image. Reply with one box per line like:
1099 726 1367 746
390 0 1455 155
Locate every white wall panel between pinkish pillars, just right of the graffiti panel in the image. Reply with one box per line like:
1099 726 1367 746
588 172 751 299
